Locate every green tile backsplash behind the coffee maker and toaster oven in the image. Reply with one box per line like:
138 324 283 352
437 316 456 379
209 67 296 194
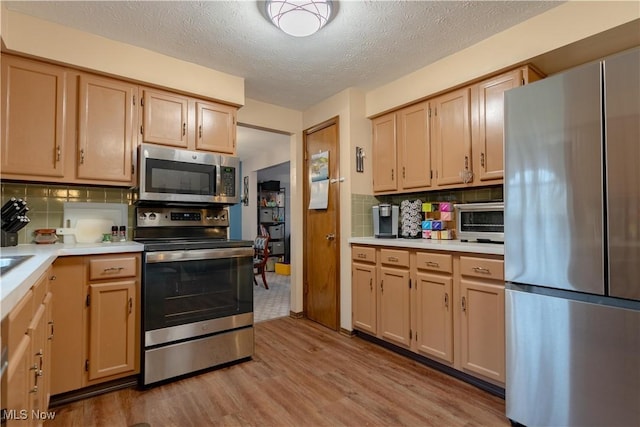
351 185 504 237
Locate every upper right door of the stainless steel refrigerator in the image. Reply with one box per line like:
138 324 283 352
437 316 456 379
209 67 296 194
604 49 640 300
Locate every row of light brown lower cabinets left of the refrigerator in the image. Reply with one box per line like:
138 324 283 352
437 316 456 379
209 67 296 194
352 245 505 386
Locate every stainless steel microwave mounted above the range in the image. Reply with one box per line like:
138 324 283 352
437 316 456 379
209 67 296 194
138 144 240 205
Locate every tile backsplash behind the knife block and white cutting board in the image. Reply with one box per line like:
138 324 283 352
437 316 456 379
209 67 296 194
0 181 135 244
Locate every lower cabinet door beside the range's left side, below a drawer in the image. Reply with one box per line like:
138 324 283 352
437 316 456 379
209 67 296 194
88 280 136 381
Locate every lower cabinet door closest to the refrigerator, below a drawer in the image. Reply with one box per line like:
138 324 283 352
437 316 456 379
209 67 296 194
460 278 505 382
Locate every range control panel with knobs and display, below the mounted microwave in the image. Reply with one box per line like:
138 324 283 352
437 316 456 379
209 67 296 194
136 207 229 227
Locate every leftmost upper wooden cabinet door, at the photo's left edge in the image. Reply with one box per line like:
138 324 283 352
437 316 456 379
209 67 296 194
0 55 66 178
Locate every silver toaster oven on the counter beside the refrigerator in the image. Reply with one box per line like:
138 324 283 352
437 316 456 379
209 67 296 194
454 202 504 243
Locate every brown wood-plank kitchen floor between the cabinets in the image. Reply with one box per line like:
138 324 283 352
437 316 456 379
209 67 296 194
45 318 509 427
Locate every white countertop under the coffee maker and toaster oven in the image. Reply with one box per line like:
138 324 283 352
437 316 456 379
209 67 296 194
349 237 504 255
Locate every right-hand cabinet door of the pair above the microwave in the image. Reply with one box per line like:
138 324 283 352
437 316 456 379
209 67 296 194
196 102 236 154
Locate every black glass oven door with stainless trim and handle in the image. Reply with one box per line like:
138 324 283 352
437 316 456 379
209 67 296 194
142 247 253 347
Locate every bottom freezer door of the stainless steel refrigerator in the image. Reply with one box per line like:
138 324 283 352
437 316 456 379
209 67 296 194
505 285 640 427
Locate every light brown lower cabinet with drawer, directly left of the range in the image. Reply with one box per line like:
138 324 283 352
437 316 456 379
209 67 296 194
51 253 140 395
